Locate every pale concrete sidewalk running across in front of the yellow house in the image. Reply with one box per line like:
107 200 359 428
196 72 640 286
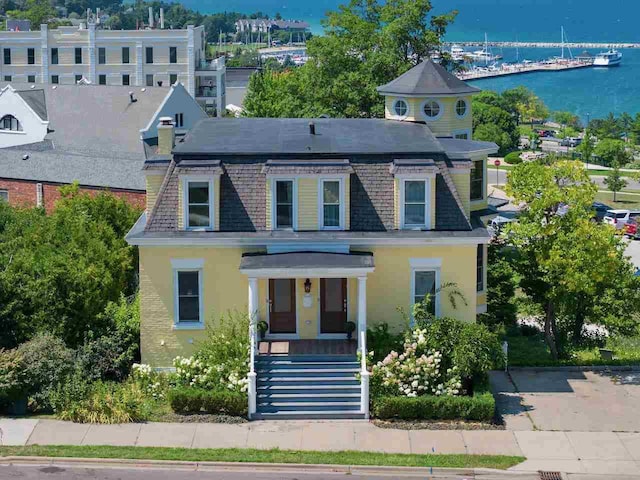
0 418 640 475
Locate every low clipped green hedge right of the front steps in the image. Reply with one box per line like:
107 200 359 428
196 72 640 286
371 385 496 422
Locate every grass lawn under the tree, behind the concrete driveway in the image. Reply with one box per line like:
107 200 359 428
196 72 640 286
504 334 640 367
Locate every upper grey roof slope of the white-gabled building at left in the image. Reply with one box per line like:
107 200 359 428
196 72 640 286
1 83 169 159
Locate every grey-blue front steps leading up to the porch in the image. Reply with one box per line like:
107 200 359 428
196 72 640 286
253 355 364 420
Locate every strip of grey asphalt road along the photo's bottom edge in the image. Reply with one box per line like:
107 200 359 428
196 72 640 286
0 465 539 480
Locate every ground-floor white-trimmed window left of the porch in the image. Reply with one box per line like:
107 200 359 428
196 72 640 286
171 259 204 329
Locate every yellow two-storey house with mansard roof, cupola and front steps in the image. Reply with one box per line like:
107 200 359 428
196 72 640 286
127 61 497 418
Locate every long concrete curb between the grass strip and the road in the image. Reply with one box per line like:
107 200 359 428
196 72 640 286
0 456 534 478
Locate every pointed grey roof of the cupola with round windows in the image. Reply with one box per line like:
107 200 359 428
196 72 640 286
377 60 480 96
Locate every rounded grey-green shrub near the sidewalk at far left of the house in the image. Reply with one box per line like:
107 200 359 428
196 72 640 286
18 333 75 410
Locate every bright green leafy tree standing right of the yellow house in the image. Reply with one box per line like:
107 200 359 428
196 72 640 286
507 161 632 358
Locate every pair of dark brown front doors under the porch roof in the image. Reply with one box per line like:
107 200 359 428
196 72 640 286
269 278 347 335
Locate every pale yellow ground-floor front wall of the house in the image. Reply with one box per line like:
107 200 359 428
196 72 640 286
140 245 486 367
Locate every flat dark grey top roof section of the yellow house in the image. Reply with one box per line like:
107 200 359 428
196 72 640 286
174 118 444 155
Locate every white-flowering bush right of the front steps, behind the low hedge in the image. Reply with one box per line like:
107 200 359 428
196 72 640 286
372 328 462 397
